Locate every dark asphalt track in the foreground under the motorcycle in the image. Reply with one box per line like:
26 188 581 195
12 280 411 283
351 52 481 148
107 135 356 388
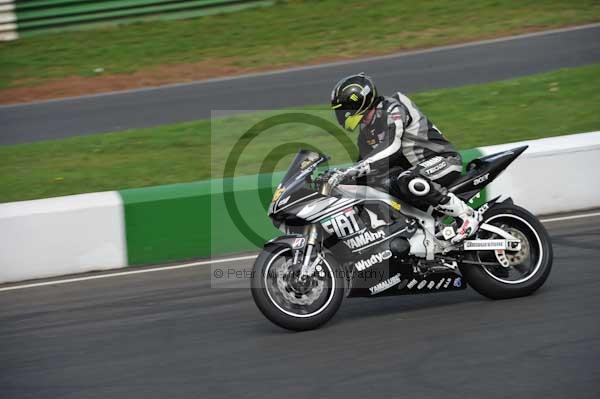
0 211 600 399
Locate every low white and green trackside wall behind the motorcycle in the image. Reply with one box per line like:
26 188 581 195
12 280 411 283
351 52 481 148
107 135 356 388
0 132 600 283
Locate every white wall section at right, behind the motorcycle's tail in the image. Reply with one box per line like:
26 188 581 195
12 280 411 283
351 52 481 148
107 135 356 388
481 132 600 215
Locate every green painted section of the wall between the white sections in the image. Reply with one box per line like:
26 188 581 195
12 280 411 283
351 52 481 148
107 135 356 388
120 149 486 265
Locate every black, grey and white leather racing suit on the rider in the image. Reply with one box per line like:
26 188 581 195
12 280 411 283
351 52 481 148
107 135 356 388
358 92 462 206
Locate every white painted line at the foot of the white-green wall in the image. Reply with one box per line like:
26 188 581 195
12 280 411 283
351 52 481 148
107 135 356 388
0 212 600 292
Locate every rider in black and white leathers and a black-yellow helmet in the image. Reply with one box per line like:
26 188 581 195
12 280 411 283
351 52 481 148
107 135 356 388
331 73 480 244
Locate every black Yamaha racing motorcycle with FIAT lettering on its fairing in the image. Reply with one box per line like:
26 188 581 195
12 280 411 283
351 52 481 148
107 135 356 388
251 146 553 331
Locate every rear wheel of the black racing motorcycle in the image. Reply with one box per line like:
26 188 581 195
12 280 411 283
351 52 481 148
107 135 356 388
460 204 553 299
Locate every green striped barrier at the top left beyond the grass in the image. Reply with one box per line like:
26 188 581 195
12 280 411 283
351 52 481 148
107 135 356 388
0 0 273 40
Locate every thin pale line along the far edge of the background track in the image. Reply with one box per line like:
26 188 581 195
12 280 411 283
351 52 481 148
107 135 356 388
0 22 600 109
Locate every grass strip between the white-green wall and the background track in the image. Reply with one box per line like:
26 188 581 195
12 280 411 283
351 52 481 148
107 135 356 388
0 65 600 202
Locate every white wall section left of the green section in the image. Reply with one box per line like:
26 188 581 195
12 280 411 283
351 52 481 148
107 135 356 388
0 192 127 283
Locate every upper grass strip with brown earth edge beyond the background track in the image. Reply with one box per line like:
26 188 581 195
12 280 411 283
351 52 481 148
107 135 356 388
0 0 600 89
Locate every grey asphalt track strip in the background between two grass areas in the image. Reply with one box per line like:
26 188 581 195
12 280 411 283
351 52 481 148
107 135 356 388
0 24 600 145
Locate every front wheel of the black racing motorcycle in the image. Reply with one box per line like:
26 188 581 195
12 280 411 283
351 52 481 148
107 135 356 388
251 246 344 331
